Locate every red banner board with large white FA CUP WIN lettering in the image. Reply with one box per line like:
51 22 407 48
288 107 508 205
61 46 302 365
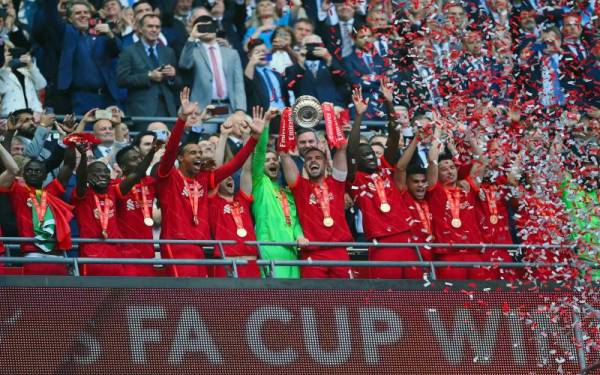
0 277 598 375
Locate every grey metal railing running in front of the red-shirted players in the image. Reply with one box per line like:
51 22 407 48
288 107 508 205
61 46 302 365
0 237 584 280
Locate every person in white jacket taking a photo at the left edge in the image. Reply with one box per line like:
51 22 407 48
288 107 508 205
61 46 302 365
0 42 46 117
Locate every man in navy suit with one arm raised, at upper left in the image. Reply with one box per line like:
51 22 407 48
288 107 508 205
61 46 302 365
45 0 119 114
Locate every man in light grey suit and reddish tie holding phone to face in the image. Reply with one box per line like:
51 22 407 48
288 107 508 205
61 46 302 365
179 16 246 114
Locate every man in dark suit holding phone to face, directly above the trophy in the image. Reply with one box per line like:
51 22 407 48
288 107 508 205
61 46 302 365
285 35 345 107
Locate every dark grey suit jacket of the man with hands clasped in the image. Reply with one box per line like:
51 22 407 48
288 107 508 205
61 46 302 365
117 41 181 116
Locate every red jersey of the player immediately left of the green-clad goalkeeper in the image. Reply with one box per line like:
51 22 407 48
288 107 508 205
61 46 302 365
210 191 256 257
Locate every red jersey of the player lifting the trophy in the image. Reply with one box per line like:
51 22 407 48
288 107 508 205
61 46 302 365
290 176 352 242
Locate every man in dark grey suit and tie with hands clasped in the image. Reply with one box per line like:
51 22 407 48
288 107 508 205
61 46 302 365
117 14 181 117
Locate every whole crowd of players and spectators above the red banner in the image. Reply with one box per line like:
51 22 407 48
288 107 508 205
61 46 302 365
0 0 600 280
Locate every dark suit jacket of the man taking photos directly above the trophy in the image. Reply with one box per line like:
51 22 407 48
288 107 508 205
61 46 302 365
285 59 345 107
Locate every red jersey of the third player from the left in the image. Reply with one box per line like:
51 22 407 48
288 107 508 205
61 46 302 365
116 177 155 258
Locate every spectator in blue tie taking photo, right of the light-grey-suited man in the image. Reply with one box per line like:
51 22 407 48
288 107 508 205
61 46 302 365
244 39 288 109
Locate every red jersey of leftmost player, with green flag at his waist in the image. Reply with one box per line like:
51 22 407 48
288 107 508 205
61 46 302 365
0 179 65 252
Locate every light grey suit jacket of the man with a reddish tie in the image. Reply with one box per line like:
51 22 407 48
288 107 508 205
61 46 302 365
179 41 246 111
